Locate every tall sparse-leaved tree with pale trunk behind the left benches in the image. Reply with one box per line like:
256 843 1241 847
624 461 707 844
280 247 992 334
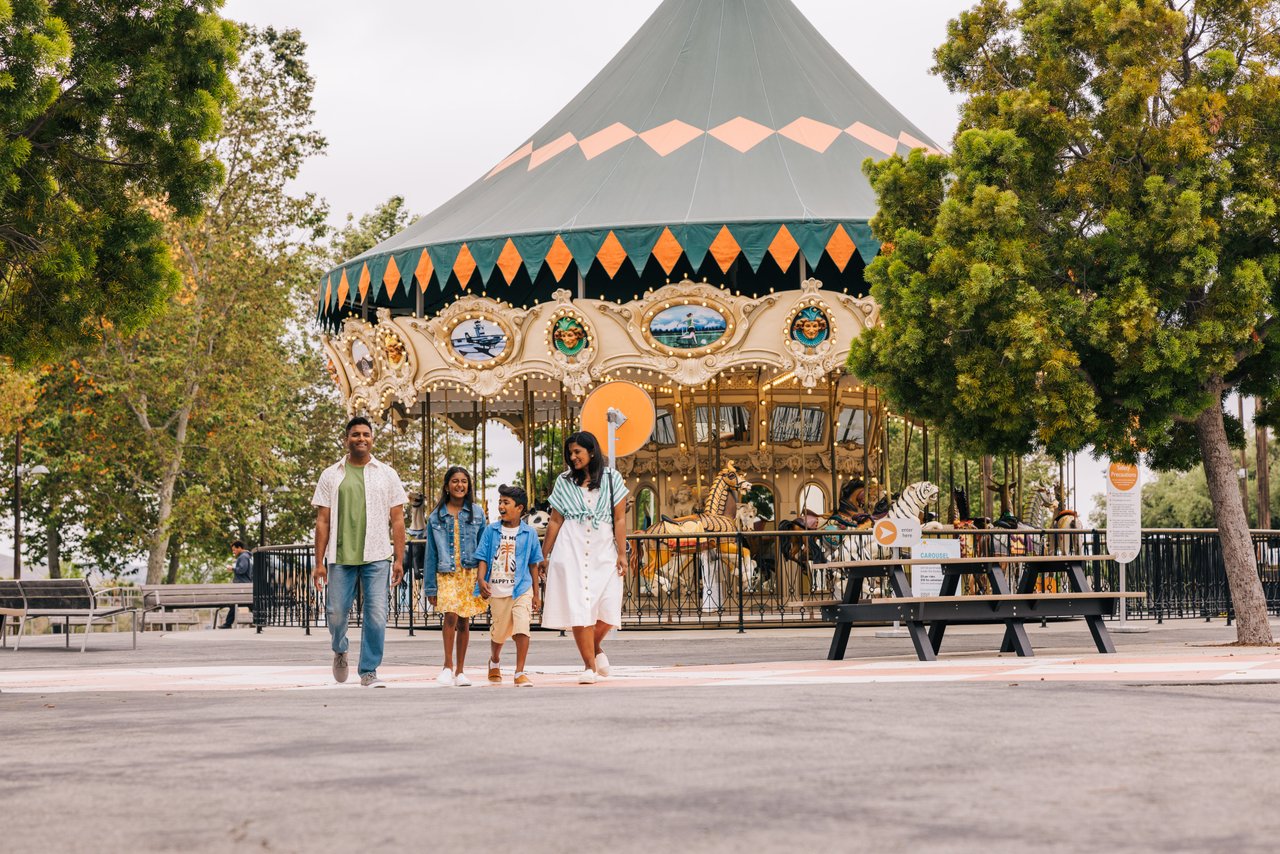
20 29 324 584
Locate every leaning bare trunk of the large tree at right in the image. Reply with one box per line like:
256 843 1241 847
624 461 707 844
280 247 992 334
1196 401 1272 645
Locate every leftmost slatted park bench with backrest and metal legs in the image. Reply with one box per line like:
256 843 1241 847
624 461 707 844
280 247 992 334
0 579 140 652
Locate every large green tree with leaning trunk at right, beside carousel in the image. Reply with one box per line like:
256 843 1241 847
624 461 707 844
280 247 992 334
850 0 1280 643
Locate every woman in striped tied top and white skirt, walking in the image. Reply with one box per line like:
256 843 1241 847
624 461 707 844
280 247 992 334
543 433 627 685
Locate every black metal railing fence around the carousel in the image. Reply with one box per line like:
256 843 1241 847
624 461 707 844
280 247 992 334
253 529 1280 634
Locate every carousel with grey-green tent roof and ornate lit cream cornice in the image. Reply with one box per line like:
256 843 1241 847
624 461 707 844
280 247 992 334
317 0 934 530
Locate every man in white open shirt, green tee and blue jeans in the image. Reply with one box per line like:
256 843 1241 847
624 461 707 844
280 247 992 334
311 415 407 688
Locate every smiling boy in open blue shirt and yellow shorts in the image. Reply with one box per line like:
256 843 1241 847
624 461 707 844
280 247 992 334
475 485 543 688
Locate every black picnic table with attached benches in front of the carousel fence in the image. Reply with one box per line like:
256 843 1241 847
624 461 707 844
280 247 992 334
792 554 1146 661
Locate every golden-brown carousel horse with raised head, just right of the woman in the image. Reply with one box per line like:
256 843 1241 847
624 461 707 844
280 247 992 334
630 460 755 606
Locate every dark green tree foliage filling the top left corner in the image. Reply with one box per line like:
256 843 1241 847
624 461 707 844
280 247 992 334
0 0 237 364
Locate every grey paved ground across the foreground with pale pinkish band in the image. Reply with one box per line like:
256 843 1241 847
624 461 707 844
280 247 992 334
0 622 1280 851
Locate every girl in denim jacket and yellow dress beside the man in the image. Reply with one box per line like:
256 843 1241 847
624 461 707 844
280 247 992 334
422 466 488 688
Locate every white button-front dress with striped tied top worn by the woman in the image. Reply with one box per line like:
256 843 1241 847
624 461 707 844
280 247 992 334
541 469 626 629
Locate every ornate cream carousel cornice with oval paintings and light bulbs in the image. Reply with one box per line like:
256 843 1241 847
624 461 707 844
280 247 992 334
323 278 879 419
